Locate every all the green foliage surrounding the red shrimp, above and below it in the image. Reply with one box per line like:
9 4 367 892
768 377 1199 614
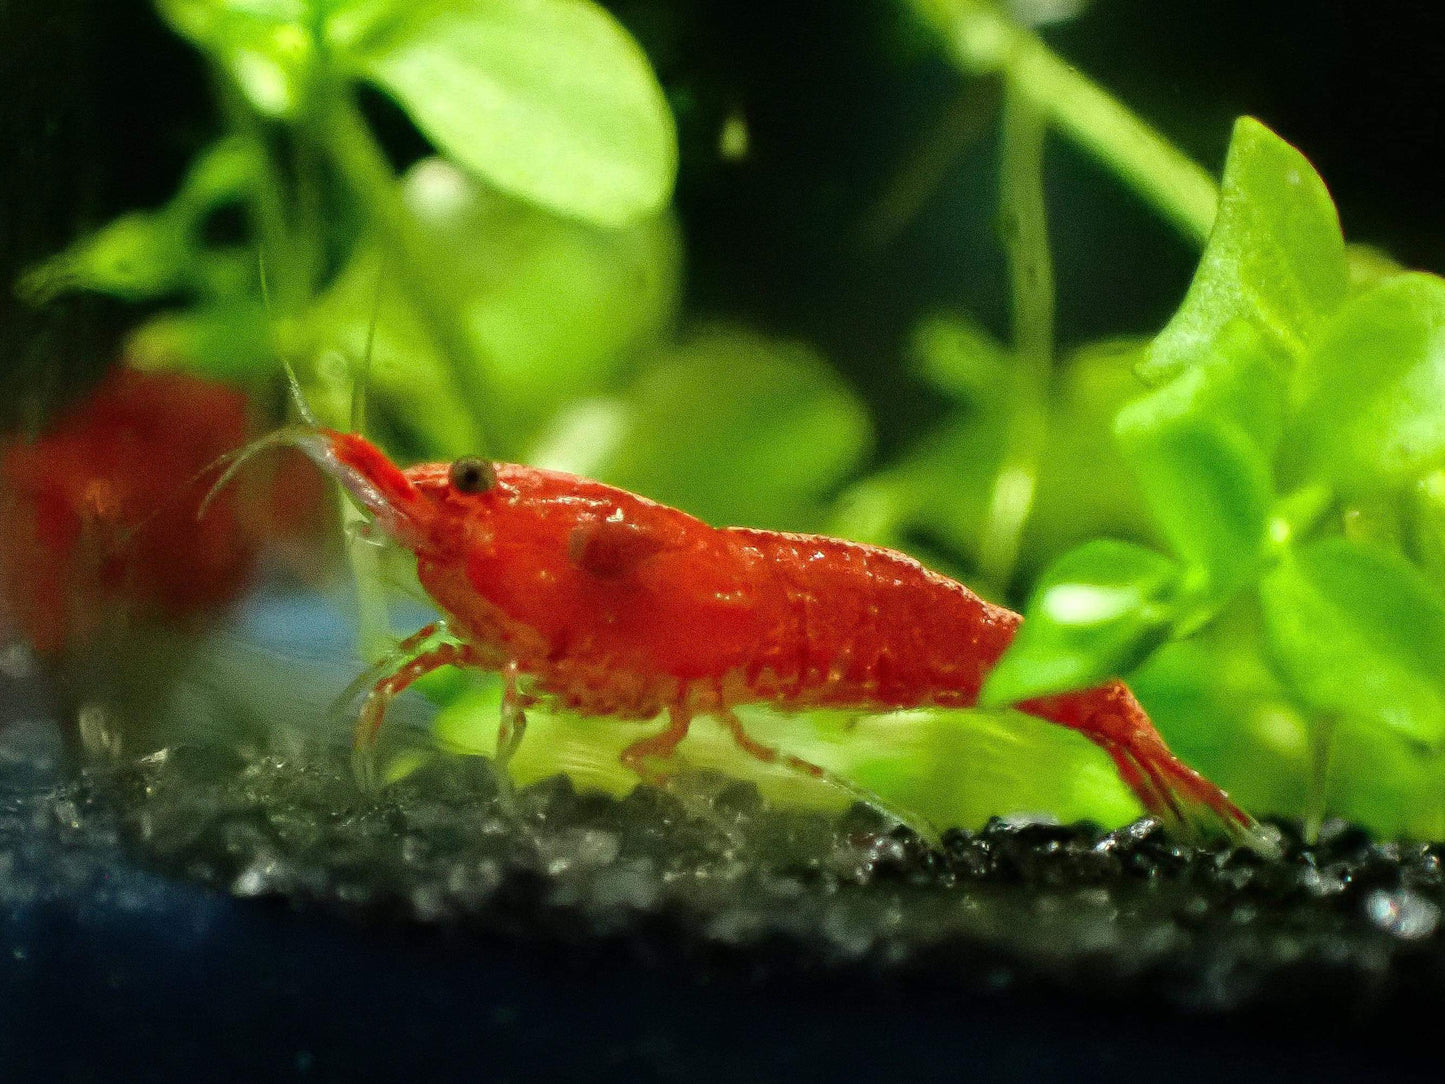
22 0 1445 834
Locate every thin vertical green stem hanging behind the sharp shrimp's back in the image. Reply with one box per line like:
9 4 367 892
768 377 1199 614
978 79 1053 591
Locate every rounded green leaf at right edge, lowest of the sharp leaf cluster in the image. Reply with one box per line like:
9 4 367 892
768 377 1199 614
1260 538 1445 747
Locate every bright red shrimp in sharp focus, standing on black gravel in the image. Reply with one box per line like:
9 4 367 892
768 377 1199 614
233 426 1269 848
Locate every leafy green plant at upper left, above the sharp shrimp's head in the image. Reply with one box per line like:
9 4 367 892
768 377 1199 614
23 0 676 454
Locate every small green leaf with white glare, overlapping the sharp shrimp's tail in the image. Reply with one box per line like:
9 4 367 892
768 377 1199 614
978 539 1181 707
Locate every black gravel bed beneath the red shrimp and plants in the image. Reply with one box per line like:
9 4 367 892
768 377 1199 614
30 747 1445 1020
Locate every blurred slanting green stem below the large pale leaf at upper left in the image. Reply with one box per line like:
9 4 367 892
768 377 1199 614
318 88 506 454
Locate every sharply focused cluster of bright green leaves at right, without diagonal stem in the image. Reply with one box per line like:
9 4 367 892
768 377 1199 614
984 119 1445 838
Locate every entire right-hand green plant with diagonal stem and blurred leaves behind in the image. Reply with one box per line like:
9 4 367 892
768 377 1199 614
838 0 1445 834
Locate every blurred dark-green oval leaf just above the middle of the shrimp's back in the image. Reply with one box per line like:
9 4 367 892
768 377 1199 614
530 325 871 530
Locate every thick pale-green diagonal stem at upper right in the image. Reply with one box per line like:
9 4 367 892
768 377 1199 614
913 0 1220 244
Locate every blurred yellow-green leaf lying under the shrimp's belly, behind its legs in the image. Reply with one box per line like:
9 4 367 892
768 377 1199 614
434 678 1139 825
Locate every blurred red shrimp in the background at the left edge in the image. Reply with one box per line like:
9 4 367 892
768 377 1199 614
0 367 322 656
